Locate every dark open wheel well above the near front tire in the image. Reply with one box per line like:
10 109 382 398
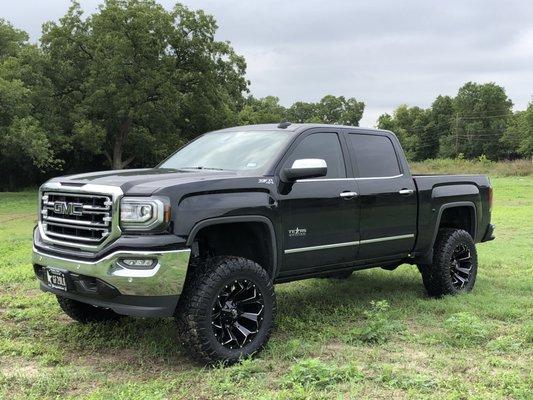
193 222 275 278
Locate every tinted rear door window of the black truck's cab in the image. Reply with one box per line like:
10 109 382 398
349 134 400 178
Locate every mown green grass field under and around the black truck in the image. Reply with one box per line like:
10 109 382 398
0 176 533 399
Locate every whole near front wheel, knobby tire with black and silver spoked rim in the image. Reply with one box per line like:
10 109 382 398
176 257 276 363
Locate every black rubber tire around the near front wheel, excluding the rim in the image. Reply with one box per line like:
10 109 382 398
175 256 276 364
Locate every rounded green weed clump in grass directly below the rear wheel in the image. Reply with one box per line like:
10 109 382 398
444 312 488 347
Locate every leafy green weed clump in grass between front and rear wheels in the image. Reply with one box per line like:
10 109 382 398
342 300 402 344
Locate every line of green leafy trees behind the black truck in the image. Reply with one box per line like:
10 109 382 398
0 0 533 190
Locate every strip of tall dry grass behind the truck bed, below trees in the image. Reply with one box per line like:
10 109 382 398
410 157 533 176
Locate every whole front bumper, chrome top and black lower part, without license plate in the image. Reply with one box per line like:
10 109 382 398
32 247 190 316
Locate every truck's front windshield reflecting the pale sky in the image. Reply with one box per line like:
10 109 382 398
159 131 292 173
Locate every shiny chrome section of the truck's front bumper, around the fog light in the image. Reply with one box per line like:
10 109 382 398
32 247 191 296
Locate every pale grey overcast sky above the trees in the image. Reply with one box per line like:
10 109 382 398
0 0 533 126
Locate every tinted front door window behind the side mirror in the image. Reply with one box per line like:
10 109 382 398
285 133 346 178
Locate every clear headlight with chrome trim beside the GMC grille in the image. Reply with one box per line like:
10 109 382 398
120 197 170 231
